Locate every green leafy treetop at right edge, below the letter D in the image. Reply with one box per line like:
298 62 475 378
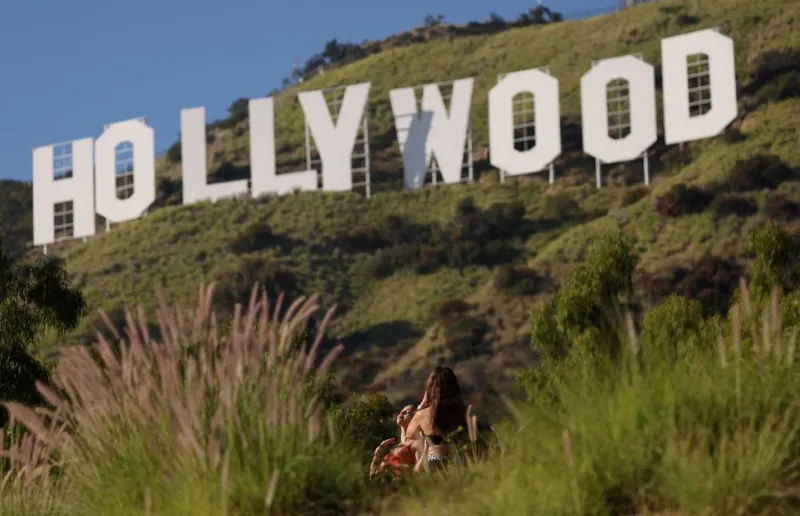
749 221 800 296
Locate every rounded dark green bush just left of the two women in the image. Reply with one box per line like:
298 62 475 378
333 393 400 464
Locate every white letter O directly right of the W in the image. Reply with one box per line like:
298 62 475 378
489 69 561 175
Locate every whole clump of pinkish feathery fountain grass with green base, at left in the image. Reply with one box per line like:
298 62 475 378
6 285 363 515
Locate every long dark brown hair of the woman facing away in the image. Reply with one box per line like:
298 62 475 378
418 366 467 436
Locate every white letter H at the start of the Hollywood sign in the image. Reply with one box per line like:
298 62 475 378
33 138 94 245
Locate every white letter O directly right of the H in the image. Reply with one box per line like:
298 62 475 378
95 120 156 223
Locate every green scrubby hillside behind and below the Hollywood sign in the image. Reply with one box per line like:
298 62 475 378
3 0 800 406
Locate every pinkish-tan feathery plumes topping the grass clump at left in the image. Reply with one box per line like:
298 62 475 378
2 285 342 504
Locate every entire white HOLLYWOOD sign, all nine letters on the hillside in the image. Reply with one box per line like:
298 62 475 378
33 29 737 246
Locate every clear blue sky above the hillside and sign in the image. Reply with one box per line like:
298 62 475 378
0 0 616 181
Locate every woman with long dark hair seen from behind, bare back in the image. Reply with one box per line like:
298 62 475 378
406 366 469 469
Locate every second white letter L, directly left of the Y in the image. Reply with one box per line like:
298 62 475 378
249 97 317 197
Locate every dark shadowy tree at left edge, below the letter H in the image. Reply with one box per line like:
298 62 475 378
0 250 86 425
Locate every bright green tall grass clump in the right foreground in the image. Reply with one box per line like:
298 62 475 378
397 282 800 514
